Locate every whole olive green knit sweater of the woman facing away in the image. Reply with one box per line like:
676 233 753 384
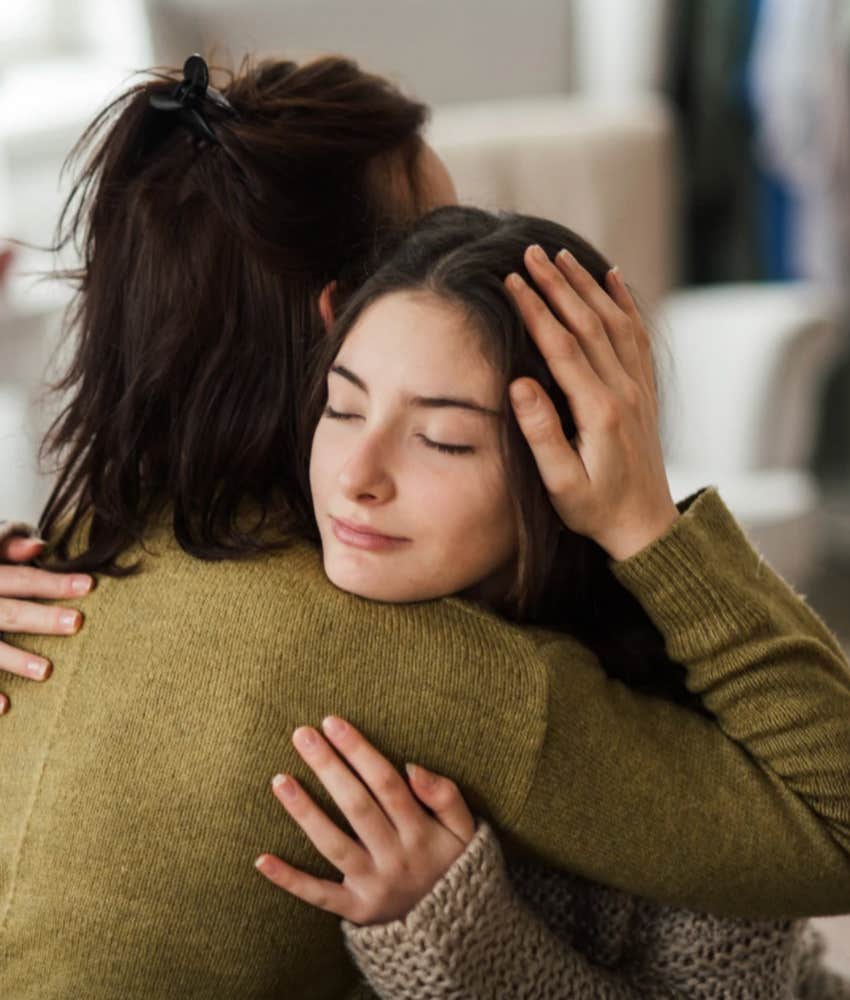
0 489 850 1000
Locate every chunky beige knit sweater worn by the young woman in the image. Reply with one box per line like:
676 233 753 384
343 823 850 1000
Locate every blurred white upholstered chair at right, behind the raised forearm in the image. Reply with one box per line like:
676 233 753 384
659 283 842 588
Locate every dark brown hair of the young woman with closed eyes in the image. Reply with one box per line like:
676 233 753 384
305 207 699 706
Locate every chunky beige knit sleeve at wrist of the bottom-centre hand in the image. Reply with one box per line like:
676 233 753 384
342 823 641 1000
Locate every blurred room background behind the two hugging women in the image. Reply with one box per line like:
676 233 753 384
0 0 850 974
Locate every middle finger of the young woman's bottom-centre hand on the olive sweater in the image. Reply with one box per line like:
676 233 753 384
292 726 401 856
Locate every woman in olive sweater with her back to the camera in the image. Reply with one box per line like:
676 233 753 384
0 54 848 998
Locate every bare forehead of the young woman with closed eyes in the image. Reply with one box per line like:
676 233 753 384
337 292 502 396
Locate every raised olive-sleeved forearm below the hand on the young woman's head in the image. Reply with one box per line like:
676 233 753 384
612 491 850 850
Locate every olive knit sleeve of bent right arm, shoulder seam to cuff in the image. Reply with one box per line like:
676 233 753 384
503 488 850 917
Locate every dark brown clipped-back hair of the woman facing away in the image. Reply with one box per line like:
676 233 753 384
41 57 426 573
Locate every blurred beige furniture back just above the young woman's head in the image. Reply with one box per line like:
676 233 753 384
429 94 675 308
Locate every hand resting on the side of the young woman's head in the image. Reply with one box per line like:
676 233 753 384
506 246 679 560
